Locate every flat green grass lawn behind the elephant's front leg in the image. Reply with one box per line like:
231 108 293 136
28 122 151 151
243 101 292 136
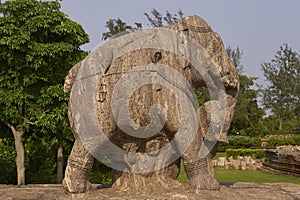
177 164 300 184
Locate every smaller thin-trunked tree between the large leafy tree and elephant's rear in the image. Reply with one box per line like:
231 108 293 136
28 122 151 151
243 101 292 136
33 84 73 183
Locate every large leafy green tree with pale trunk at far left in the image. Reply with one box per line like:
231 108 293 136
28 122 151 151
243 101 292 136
0 0 88 185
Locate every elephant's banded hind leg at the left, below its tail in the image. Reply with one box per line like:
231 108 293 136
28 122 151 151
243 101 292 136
62 139 94 193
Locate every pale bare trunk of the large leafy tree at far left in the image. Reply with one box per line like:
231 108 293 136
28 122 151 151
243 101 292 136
7 124 25 185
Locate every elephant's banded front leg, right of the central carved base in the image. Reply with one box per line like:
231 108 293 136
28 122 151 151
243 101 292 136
182 128 220 190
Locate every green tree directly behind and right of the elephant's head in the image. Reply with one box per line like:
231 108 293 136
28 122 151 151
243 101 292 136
226 46 265 136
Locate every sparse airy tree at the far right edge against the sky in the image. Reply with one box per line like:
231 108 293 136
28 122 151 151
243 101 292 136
261 44 300 131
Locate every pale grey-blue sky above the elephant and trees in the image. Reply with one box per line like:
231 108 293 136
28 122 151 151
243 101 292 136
62 0 300 82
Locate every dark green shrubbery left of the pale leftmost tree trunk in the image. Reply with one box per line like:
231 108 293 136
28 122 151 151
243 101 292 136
0 138 17 184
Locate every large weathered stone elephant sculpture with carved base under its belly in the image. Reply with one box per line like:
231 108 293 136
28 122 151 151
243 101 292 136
63 16 239 193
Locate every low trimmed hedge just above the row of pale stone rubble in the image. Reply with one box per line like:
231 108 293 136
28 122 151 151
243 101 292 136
226 149 266 159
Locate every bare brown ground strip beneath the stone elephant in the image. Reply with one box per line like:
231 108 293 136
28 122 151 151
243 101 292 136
0 183 300 200
